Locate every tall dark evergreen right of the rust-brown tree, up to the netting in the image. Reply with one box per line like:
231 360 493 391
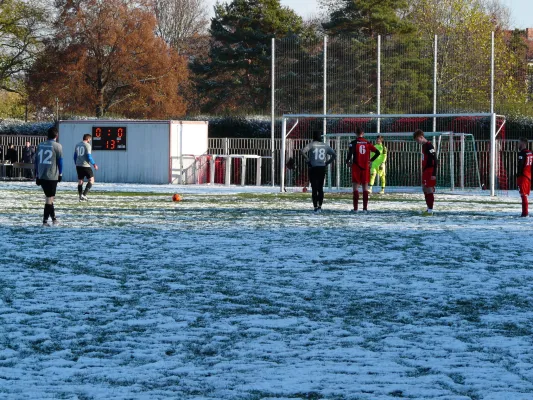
192 0 305 113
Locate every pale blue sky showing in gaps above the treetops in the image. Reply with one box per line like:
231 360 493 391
207 0 533 29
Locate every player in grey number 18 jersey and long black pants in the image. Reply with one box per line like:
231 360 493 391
302 131 337 212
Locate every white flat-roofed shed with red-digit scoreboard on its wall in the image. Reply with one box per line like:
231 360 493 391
58 120 208 184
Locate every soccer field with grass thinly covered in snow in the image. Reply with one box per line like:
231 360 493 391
0 183 533 400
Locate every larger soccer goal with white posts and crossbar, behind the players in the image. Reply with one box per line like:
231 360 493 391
280 113 504 195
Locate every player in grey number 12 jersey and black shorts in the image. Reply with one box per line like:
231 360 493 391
35 127 63 226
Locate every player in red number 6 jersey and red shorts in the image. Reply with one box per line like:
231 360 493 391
346 128 380 211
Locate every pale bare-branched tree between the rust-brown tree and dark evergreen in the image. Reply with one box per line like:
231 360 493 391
154 0 208 53
